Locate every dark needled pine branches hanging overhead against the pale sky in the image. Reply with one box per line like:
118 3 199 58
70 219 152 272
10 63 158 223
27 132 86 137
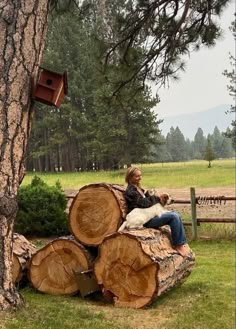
104 0 230 91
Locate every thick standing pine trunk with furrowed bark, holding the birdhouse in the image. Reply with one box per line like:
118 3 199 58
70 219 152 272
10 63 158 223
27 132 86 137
0 0 49 309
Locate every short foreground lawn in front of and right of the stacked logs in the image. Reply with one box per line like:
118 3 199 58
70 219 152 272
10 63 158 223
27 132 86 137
0 241 235 329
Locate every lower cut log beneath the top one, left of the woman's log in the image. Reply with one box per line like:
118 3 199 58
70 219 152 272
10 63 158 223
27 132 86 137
28 236 94 295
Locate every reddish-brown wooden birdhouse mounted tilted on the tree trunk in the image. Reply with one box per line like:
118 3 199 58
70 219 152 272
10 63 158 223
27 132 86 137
33 68 68 108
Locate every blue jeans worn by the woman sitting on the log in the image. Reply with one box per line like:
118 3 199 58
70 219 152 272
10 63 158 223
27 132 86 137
143 211 186 246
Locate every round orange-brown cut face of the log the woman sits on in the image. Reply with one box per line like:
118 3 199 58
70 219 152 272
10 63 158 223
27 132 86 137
95 234 158 308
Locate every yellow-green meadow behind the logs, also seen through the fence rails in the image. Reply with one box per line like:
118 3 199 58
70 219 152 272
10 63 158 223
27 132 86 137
22 159 235 239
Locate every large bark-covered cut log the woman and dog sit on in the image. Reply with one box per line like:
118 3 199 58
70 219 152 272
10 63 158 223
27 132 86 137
94 226 195 308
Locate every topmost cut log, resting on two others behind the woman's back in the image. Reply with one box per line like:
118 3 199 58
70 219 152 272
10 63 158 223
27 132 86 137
69 183 127 246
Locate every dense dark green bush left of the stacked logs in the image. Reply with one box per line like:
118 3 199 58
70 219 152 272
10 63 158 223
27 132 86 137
14 176 69 237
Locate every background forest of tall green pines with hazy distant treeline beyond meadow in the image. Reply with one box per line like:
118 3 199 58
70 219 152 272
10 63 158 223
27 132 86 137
26 6 234 172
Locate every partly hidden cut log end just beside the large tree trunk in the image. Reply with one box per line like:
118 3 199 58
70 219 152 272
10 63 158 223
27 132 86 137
13 233 37 283
